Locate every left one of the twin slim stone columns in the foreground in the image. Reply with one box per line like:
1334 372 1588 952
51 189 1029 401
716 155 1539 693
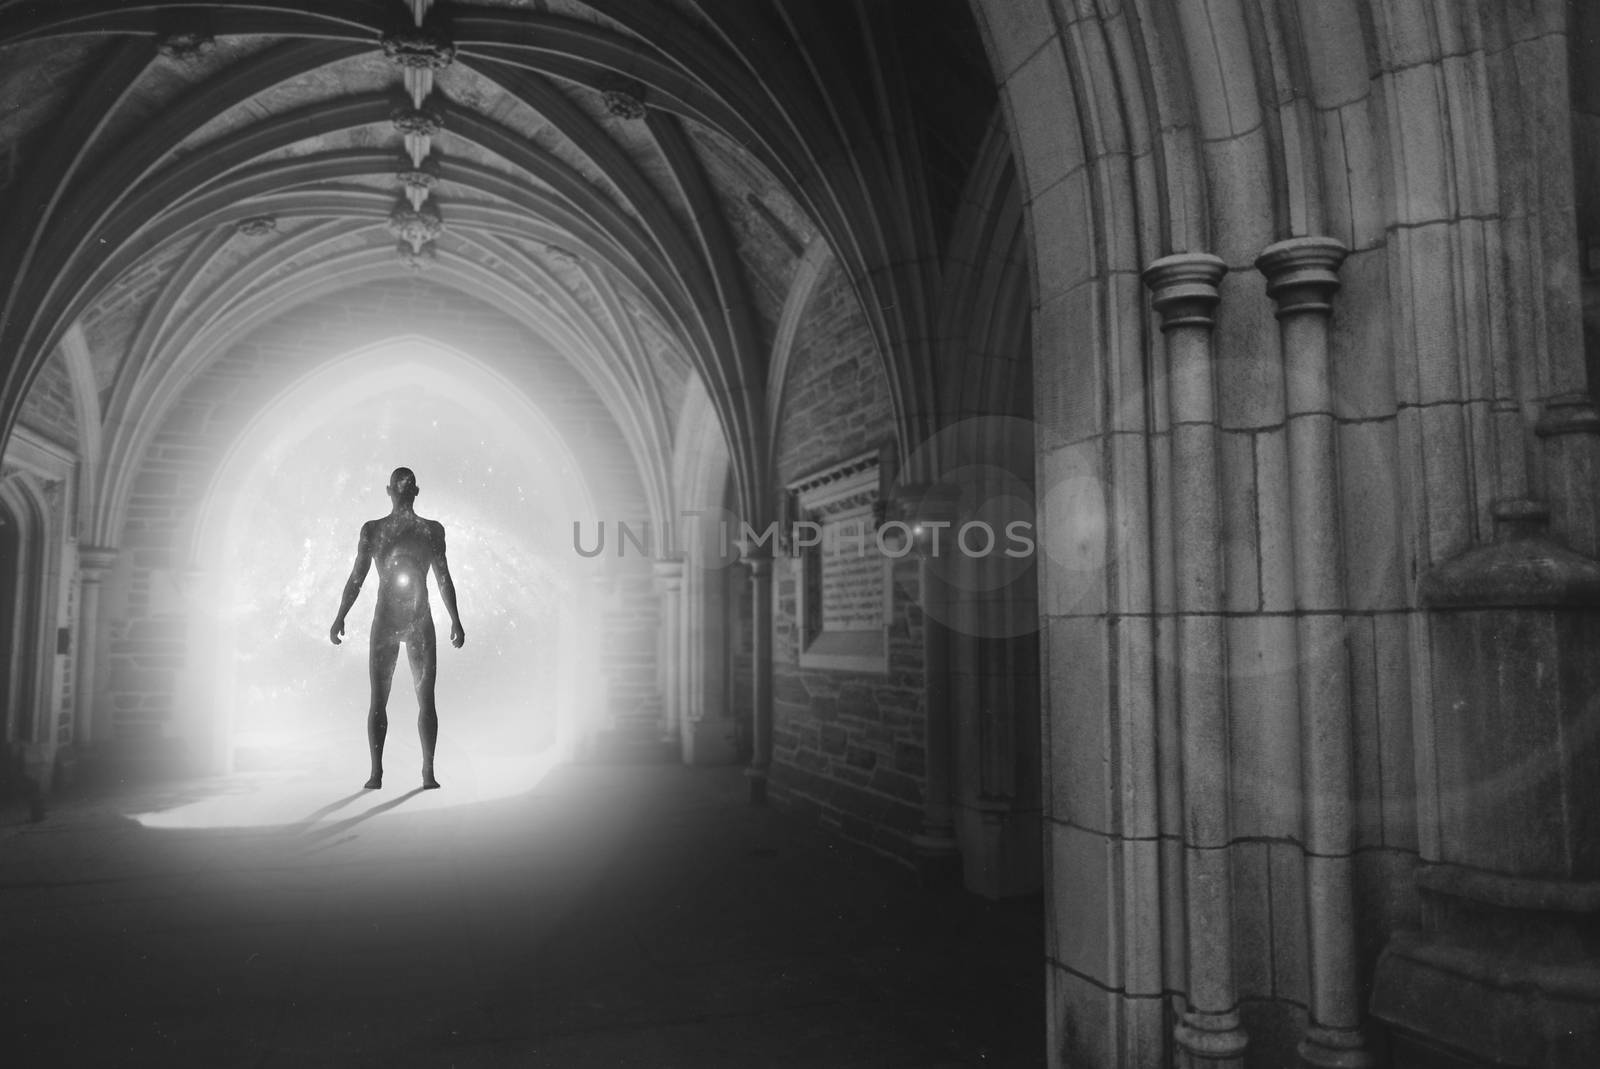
1144 253 1248 1069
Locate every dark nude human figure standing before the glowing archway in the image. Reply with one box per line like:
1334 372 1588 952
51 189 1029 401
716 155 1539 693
328 467 467 791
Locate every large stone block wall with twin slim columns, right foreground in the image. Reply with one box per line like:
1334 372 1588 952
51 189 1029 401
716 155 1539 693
974 0 1600 1069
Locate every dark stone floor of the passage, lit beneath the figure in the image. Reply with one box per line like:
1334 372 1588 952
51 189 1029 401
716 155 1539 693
0 765 1043 1069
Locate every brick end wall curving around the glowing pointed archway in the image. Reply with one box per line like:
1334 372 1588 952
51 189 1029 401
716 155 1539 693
104 278 654 748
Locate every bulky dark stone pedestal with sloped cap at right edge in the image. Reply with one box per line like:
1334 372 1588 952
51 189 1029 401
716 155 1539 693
1371 502 1600 1069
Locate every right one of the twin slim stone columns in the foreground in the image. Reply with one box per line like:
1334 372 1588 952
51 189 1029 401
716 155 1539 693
1256 237 1373 1067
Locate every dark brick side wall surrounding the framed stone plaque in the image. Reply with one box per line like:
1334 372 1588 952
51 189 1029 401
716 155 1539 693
771 269 925 856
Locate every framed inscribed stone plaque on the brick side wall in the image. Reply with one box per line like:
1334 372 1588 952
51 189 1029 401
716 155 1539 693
789 451 890 672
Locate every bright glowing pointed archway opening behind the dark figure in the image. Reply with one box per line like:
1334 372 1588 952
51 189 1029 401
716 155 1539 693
141 338 597 826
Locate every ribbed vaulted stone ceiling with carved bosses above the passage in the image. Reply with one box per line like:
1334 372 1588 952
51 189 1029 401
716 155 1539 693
0 0 994 531
